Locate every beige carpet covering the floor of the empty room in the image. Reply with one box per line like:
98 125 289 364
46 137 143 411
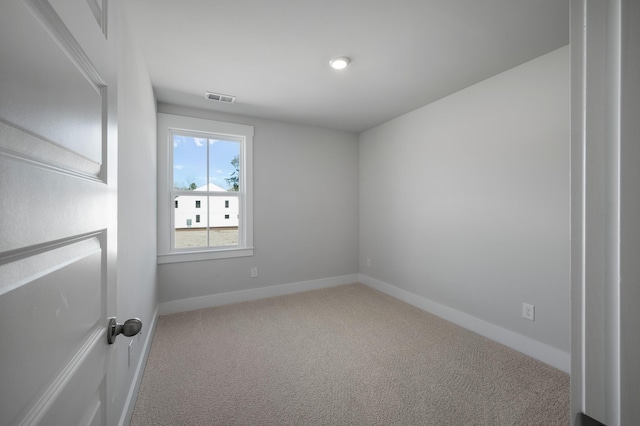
131 284 569 426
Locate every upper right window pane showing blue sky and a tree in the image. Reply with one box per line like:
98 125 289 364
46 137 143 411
209 139 241 191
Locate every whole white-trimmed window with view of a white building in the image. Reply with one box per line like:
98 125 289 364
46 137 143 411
158 113 253 263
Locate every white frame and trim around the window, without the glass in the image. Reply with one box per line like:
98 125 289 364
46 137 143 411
158 113 254 264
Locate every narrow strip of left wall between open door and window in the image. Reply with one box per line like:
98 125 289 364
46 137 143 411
115 10 158 424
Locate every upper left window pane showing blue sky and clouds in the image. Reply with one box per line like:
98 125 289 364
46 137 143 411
173 134 207 190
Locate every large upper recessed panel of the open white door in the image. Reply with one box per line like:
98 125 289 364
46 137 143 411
0 0 104 163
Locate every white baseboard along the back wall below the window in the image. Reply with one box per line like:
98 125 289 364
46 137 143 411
160 274 359 315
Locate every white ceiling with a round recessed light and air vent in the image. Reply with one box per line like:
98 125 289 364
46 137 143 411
123 0 569 133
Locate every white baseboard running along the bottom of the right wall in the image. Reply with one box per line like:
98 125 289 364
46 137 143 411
359 274 571 373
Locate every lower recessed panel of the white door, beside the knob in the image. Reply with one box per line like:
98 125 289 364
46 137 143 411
0 237 105 418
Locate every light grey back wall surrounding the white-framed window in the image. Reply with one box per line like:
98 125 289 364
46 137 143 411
158 103 358 302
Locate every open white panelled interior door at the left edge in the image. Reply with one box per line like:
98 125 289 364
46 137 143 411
0 0 117 426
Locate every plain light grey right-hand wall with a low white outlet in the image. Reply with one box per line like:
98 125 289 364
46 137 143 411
359 46 570 353
